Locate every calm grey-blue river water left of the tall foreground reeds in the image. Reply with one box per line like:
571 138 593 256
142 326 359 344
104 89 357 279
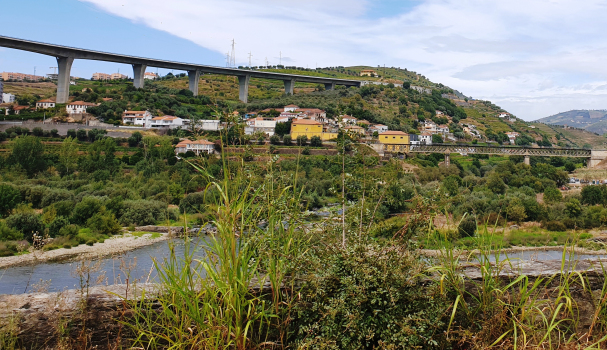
0 240 208 294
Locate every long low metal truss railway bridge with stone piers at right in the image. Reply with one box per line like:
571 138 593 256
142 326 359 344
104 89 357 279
376 144 607 168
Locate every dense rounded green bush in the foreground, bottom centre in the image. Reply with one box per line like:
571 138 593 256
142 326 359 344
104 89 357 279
293 244 449 350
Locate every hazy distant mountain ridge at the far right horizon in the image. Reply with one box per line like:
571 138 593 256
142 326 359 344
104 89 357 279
536 109 607 135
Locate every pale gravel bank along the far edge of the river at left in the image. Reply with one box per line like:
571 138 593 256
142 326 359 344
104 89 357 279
0 233 170 269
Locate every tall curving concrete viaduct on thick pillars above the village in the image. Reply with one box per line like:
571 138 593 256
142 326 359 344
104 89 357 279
0 36 367 103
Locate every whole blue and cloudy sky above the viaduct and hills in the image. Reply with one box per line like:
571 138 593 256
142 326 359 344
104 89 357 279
0 0 607 120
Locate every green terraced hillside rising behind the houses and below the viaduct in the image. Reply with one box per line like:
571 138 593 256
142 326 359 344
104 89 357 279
2 66 556 146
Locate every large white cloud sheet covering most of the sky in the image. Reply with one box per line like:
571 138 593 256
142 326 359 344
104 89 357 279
81 0 607 119
